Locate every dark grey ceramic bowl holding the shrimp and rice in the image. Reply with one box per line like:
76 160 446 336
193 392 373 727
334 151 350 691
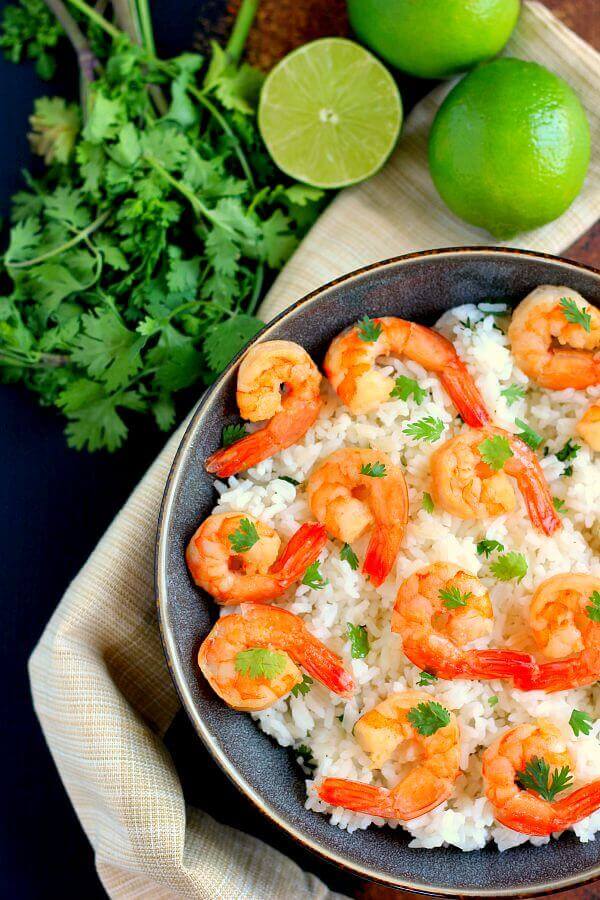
156 248 600 897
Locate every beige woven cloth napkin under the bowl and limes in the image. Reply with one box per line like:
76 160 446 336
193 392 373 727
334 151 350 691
30 3 600 900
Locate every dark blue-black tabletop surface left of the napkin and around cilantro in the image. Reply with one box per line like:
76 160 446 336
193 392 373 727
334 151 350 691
0 0 423 900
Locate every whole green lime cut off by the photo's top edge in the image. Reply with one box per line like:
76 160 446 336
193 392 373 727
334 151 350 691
348 0 519 78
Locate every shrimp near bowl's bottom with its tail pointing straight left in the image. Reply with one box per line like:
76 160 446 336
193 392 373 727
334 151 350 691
317 691 460 822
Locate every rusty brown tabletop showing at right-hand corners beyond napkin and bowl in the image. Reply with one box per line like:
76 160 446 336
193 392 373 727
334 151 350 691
354 7 600 900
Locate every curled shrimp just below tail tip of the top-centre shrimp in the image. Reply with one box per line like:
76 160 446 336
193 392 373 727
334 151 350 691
431 425 561 534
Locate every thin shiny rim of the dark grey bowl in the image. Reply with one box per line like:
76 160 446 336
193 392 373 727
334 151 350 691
154 246 600 898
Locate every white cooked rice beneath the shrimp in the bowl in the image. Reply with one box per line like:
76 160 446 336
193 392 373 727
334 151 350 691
211 304 600 850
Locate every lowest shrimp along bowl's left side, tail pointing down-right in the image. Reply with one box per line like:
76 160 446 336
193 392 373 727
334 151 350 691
198 603 354 712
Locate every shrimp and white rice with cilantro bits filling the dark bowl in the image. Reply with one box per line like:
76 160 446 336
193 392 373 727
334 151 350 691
187 287 600 851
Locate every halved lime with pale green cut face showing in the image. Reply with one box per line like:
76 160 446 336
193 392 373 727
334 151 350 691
258 38 402 188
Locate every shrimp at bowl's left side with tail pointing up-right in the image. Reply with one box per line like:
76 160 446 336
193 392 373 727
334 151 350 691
185 513 327 605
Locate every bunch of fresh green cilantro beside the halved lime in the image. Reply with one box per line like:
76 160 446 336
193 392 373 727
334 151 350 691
0 0 322 450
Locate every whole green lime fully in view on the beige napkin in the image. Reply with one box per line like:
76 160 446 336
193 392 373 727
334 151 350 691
429 58 590 238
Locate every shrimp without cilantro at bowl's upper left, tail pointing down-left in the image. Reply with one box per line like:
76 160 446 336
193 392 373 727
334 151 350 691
206 341 321 478
